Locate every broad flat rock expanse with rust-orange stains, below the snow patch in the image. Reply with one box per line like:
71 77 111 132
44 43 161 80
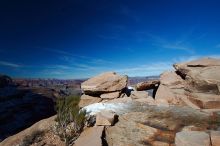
106 105 209 146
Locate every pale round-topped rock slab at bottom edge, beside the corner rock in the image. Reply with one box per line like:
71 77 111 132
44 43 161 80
175 131 211 146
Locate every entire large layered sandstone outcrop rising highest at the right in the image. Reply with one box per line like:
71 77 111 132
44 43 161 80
155 58 220 111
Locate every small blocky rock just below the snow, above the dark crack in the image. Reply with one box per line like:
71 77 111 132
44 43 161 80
96 110 117 126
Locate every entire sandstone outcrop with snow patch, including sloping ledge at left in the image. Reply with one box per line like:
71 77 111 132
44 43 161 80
0 58 220 146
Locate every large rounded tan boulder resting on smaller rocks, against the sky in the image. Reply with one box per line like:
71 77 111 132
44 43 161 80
81 72 128 95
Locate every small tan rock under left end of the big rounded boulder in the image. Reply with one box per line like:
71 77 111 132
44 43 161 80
79 94 102 107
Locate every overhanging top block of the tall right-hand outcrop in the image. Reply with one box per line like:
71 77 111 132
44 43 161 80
174 58 220 94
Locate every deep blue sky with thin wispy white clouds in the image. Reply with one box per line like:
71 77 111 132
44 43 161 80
0 0 220 79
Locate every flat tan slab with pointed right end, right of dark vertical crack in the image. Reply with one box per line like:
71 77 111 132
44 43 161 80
106 114 157 146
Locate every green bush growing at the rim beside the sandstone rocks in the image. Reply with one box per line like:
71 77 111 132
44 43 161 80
56 96 86 145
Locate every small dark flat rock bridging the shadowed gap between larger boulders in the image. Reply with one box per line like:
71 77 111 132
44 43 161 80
135 80 160 91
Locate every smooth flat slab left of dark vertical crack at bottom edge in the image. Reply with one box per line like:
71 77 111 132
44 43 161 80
74 126 104 146
